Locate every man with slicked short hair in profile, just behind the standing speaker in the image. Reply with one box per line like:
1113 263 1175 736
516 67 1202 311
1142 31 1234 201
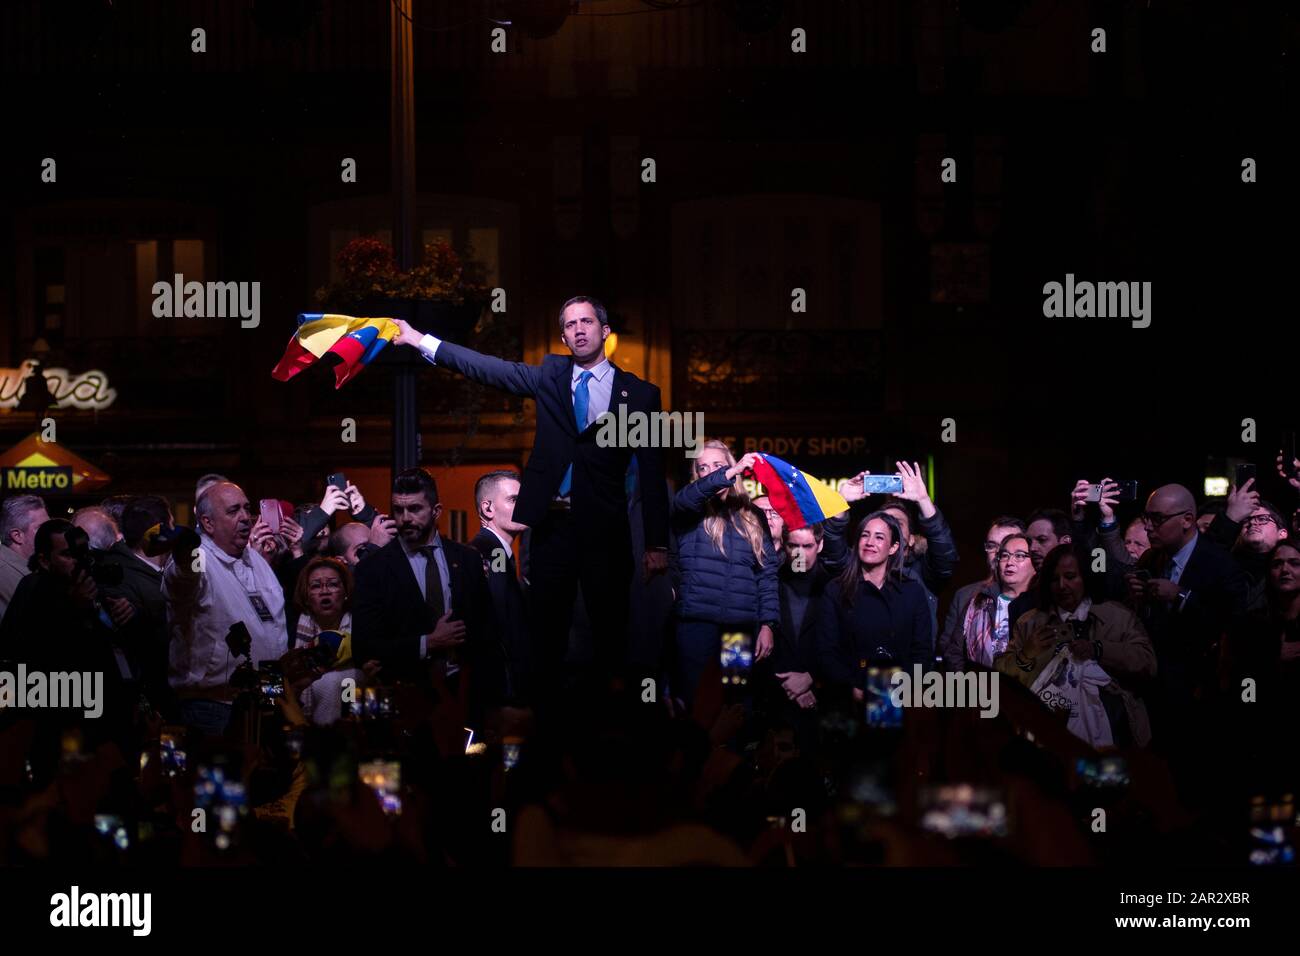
469 471 530 701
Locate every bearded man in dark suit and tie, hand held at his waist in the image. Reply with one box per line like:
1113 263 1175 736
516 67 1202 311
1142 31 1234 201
352 468 497 701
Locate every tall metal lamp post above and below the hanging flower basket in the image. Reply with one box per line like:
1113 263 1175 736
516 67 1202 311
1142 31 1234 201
389 0 420 476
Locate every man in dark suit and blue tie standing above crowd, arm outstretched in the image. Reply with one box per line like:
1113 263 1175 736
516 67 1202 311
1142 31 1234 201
397 297 668 693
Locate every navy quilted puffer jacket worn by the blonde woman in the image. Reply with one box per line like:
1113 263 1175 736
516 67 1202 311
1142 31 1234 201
668 468 781 630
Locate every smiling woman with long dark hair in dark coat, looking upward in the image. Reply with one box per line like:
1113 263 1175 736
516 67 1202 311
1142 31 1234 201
818 511 935 697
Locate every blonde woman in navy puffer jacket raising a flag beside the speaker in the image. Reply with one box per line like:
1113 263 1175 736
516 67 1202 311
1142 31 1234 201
670 440 781 706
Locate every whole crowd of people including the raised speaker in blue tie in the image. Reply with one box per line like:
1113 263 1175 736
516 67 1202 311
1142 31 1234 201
0 299 1300 865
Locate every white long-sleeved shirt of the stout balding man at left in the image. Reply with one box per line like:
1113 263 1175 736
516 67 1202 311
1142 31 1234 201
163 535 289 689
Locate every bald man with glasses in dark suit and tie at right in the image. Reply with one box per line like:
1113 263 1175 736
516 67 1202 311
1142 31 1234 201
1127 485 1247 780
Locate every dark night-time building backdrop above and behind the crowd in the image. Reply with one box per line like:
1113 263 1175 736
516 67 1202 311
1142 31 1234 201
0 0 1300 595
